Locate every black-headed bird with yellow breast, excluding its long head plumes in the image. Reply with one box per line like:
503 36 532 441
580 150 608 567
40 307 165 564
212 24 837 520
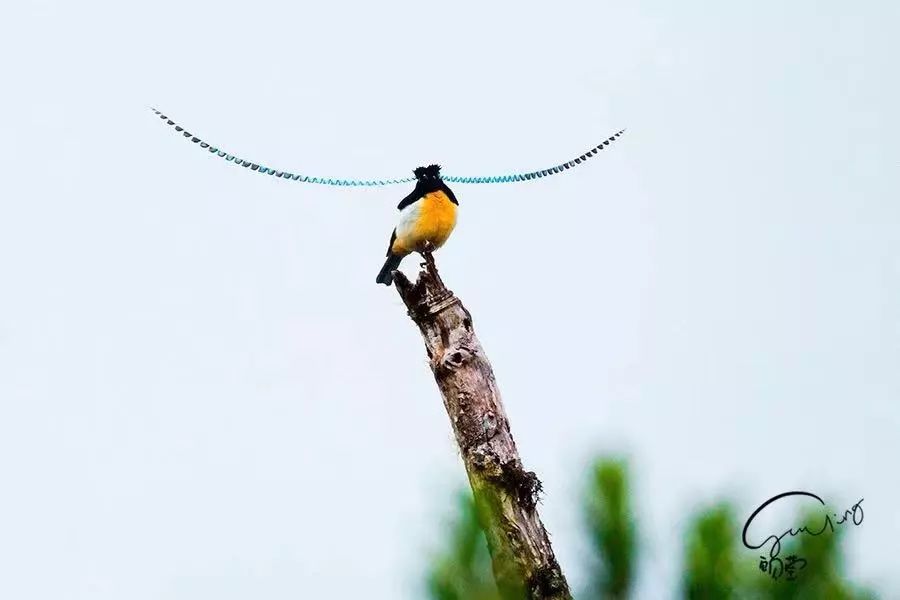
375 165 459 285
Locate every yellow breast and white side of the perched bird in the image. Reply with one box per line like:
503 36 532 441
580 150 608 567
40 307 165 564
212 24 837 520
391 190 456 255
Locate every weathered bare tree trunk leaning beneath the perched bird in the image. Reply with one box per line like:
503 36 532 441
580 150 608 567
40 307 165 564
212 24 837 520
394 253 572 600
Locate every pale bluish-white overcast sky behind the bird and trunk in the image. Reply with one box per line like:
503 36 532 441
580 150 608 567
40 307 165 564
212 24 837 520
0 0 900 600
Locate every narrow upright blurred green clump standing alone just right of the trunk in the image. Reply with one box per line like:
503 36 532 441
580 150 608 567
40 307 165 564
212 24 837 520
580 459 636 600
